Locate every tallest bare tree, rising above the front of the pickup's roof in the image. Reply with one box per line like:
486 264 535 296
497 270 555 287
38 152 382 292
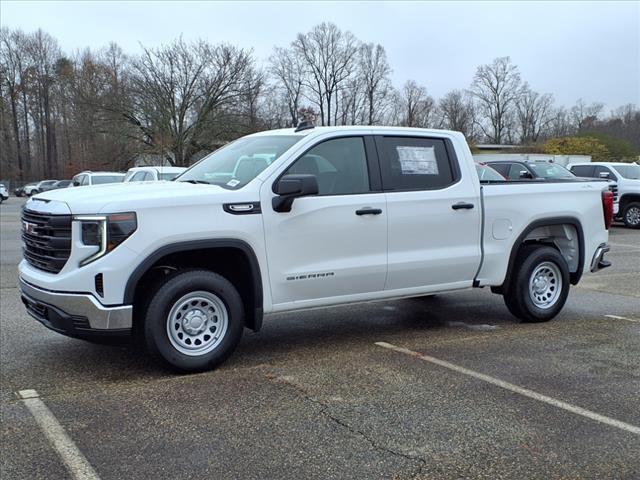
292 22 358 125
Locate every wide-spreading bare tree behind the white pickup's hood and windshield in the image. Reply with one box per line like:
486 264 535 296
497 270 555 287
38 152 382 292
130 39 252 165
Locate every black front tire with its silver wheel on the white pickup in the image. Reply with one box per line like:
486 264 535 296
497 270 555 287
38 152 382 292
144 270 244 372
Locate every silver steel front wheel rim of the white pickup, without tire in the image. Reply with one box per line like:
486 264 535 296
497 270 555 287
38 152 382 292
167 291 229 357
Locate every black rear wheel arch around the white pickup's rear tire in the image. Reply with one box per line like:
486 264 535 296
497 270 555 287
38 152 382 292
492 217 585 293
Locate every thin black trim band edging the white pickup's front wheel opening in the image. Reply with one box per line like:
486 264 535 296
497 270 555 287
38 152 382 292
124 238 264 332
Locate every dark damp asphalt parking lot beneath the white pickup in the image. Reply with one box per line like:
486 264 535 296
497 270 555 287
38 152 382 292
0 197 640 479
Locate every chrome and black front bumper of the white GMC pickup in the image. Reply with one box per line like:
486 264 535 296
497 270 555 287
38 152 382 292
19 278 133 338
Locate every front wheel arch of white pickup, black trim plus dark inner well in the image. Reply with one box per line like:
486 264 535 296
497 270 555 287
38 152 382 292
124 239 263 331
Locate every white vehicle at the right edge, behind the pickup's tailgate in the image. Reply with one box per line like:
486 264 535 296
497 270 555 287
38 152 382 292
569 162 640 228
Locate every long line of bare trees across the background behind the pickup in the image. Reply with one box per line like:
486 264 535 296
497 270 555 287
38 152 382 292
0 23 640 180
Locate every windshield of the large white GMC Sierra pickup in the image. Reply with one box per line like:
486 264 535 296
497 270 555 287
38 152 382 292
177 135 303 190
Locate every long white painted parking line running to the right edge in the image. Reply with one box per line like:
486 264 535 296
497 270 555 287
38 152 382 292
376 342 640 435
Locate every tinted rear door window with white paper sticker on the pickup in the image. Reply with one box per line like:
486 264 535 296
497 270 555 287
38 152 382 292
376 136 457 191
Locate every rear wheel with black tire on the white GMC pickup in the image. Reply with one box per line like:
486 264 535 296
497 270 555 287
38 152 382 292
503 245 570 323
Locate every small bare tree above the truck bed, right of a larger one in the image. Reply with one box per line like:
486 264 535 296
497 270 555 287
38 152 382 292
516 83 553 144
